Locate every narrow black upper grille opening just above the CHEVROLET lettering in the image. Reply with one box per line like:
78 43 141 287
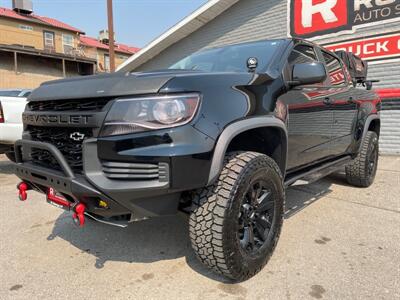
28 99 109 112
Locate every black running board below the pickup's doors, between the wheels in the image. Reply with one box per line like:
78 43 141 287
285 156 352 187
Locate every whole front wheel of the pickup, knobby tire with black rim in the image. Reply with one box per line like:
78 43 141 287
189 152 285 281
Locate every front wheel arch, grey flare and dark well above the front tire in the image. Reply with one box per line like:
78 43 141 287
208 116 288 185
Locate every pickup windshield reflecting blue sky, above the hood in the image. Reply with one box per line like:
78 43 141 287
169 40 282 72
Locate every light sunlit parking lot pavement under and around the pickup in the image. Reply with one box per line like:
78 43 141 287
0 156 400 299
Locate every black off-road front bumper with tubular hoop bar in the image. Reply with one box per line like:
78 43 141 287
11 125 213 221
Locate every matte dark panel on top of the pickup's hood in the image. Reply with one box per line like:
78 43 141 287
28 70 202 101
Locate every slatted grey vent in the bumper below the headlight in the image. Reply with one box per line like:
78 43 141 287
102 162 169 182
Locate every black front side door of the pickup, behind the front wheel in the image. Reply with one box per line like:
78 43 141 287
278 44 334 172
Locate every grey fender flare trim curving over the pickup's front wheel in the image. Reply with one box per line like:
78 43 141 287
207 116 288 185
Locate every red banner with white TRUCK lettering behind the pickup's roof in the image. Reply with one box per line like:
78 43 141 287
325 34 400 60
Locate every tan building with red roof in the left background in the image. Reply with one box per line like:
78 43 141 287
0 1 138 89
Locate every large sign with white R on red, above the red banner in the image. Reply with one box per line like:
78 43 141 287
289 0 400 38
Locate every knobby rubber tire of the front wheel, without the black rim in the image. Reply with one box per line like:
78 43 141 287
189 152 283 280
